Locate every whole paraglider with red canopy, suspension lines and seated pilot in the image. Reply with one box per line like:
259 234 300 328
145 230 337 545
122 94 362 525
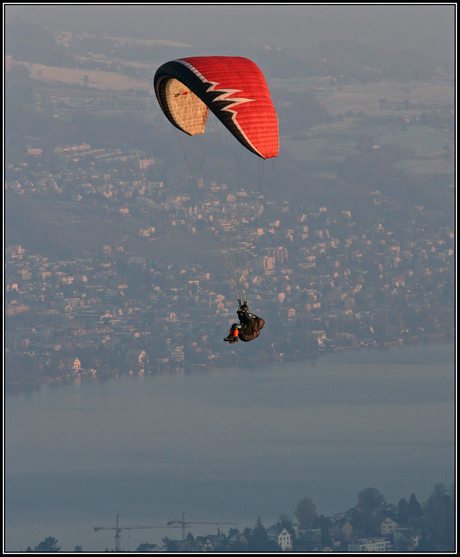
154 56 279 342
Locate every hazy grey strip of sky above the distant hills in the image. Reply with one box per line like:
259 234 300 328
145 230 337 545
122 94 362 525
6 4 455 60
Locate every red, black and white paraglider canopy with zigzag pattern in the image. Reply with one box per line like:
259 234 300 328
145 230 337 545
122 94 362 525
154 56 279 159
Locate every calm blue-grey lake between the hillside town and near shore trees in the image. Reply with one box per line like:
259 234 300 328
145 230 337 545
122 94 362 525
5 344 455 551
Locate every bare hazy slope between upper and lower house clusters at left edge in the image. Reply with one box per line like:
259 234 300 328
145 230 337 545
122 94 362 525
6 194 217 263
